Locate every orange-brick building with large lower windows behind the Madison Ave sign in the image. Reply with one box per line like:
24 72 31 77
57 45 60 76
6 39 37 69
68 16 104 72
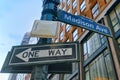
51 0 120 80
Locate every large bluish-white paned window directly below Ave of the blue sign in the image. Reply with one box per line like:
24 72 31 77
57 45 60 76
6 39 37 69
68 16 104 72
83 33 106 60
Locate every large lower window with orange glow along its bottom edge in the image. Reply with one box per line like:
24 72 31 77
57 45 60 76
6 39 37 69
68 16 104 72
85 49 117 80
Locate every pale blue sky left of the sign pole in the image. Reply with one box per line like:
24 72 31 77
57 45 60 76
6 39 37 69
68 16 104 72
0 0 42 80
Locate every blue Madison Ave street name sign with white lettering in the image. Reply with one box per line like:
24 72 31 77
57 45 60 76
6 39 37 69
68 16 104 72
57 10 111 36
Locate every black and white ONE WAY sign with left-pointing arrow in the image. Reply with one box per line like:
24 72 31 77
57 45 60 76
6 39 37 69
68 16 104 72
9 42 79 65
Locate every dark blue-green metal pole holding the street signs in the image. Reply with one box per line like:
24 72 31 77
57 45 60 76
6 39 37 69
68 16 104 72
31 0 60 80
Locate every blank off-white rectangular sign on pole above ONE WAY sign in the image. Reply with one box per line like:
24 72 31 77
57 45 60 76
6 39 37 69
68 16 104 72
30 20 59 38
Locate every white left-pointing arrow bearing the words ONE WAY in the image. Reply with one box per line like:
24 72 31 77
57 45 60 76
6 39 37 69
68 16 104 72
16 48 72 62
